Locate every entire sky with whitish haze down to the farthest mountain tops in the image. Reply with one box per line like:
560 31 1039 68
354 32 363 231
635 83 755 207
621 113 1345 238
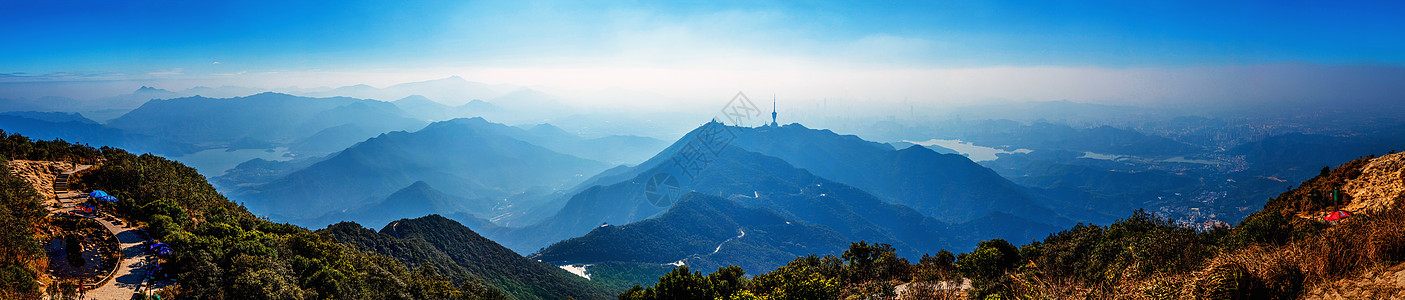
0 1 1405 111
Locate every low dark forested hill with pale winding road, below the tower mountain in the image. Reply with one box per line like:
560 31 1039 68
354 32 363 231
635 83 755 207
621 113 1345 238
530 193 849 269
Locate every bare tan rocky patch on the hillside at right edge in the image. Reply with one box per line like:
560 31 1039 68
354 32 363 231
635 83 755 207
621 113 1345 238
1342 153 1405 213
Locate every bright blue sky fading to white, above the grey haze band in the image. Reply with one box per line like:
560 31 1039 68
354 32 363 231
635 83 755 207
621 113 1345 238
0 0 1405 105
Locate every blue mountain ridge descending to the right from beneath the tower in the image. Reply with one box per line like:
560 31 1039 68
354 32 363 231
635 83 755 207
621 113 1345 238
732 123 1071 224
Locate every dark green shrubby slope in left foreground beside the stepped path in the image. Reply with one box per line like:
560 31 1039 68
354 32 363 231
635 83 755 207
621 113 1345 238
0 135 494 299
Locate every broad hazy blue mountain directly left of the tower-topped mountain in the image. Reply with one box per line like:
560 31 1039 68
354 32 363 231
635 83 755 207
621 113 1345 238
235 119 607 219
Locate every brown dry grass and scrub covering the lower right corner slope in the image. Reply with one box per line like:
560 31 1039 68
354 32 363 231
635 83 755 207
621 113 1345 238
1012 190 1405 299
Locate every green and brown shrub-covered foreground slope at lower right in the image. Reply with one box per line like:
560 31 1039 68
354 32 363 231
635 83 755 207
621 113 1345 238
632 153 1405 299
